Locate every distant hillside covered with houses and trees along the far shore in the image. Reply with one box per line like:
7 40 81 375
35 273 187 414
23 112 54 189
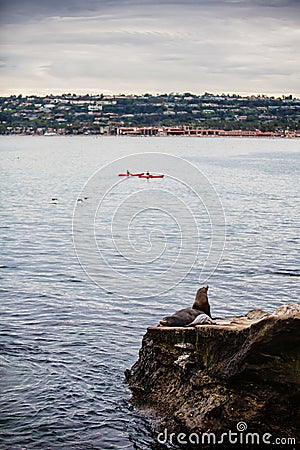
0 93 300 137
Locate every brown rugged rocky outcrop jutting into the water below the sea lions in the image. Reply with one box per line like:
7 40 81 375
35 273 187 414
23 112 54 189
125 304 300 442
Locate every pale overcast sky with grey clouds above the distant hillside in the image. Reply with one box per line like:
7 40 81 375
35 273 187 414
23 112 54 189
0 0 300 98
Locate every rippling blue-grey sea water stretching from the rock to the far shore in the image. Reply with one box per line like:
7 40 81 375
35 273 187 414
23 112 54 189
0 137 300 450
